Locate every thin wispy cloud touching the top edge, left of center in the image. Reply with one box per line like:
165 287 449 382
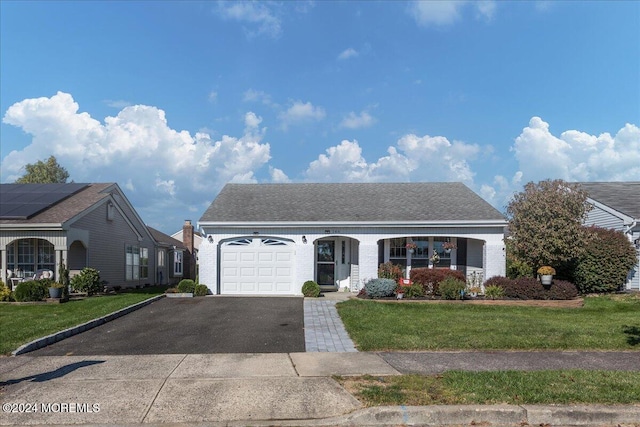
218 1 282 38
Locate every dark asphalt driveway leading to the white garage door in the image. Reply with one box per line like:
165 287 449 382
29 297 305 356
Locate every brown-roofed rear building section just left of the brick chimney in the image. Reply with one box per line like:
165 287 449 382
147 226 189 285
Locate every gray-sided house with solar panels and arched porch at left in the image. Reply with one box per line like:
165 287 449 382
0 183 158 287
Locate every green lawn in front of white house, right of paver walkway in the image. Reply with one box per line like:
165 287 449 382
337 296 640 351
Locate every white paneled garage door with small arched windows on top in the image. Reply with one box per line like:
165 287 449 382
220 237 295 295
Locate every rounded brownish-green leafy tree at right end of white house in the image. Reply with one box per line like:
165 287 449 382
507 180 591 272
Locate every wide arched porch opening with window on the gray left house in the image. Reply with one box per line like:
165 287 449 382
7 239 56 277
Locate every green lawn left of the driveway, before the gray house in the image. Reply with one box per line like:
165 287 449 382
0 287 166 355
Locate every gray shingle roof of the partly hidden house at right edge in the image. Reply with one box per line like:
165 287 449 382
578 181 640 219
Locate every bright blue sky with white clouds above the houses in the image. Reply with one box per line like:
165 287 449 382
0 0 640 233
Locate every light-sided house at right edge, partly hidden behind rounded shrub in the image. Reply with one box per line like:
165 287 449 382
578 181 640 290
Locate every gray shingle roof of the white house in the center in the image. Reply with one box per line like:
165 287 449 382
200 182 505 223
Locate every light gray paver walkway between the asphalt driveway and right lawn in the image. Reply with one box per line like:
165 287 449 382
304 292 358 353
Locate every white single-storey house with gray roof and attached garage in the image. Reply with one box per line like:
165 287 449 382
198 183 507 295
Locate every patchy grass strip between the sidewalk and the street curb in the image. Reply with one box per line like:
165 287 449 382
334 370 640 406
